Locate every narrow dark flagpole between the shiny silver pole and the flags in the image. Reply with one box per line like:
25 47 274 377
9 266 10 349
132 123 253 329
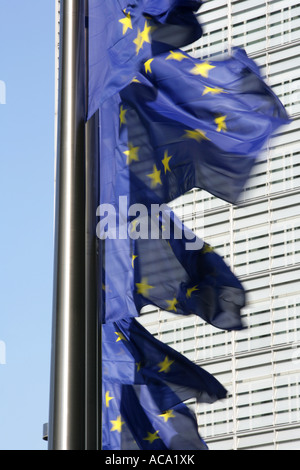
85 109 102 450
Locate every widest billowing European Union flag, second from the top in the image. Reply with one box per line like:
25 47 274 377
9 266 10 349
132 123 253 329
117 49 289 204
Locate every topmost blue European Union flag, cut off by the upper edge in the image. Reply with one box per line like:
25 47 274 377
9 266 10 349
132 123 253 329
88 0 202 118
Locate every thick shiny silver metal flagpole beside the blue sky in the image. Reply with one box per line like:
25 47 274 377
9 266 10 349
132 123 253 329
48 0 85 450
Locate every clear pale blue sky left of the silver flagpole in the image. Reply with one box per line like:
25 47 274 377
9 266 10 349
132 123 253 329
0 0 55 450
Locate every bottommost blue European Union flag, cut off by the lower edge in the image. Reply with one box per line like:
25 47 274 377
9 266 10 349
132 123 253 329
102 382 208 450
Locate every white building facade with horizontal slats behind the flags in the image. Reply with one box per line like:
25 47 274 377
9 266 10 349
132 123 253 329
140 0 300 450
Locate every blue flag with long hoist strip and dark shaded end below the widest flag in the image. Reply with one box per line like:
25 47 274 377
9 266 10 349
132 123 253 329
97 79 245 330
